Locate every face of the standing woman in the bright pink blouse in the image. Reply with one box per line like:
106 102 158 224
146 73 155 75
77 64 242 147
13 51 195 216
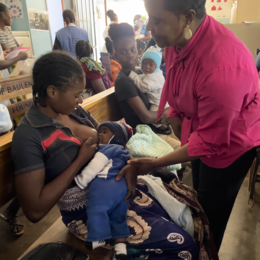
145 0 186 48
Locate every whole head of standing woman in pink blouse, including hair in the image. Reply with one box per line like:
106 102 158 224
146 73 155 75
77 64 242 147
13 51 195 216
145 0 206 48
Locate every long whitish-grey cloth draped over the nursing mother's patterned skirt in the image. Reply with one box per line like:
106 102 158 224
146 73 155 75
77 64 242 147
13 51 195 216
140 175 194 238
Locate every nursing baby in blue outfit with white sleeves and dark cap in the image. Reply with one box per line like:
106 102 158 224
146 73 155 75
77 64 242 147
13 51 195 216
75 121 135 260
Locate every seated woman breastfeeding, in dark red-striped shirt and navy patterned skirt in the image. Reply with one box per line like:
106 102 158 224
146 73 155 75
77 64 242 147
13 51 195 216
12 52 200 260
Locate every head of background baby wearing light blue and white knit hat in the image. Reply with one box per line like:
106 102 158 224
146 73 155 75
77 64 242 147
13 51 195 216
141 46 162 74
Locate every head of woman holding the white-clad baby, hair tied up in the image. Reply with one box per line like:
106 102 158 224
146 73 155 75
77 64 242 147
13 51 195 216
108 23 138 70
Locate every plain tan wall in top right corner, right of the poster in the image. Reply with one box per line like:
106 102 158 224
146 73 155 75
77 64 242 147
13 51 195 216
237 0 260 23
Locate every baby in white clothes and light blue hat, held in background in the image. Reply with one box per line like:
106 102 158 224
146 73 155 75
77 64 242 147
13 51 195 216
129 46 171 135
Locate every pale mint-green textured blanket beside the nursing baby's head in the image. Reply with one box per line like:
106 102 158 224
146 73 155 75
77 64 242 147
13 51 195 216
126 125 181 171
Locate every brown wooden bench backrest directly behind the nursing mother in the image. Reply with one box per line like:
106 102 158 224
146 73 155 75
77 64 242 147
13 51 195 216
0 88 122 207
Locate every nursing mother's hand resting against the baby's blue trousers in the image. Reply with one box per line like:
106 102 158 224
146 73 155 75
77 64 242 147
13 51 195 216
116 165 138 205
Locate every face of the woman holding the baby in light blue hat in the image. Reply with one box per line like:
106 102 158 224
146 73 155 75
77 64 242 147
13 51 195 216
115 38 138 70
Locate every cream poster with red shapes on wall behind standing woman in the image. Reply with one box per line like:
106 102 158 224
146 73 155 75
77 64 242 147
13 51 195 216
206 0 232 19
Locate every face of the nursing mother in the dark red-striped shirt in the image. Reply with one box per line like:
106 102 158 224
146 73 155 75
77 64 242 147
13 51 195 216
47 81 86 115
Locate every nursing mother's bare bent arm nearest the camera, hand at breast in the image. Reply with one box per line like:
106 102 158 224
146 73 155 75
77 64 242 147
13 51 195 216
15 138 97 223
